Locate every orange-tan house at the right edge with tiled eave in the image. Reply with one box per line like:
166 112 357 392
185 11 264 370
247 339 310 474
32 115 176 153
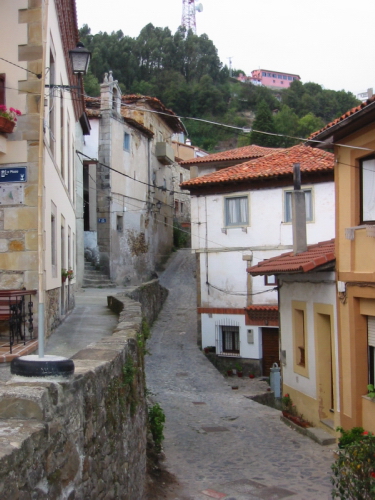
309 97 375 432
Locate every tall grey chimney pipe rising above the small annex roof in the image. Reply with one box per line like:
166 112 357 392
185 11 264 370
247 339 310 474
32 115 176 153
292 163 307 255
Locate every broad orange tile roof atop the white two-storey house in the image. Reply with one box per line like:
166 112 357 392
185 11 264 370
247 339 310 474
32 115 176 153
181 145 334 189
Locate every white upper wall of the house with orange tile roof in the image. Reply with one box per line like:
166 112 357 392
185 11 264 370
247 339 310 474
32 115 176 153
191 182 335 307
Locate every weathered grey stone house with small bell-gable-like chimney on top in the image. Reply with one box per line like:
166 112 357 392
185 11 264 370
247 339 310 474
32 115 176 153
82 80 183 285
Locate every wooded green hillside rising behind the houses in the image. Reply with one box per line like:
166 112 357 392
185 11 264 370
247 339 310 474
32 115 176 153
80 24 359 151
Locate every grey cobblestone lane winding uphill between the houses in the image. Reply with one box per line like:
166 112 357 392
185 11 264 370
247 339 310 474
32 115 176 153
146 250 333 500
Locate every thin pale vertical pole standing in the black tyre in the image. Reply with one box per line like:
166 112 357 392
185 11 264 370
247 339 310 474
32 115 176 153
38 0 49 358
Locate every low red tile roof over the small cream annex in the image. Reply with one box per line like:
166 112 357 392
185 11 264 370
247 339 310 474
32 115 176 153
247 239 336 276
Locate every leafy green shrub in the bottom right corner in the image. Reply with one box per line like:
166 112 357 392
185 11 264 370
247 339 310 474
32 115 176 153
331 427 375 500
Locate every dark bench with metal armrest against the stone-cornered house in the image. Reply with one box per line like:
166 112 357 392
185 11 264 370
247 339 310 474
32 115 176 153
0 289 36 353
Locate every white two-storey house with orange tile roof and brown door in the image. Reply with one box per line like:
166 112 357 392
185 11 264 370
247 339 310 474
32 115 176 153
182 146 334 374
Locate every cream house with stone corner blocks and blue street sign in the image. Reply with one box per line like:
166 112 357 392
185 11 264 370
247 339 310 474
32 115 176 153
0 0 89 342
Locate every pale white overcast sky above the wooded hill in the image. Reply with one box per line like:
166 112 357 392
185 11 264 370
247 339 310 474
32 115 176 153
76 0 375 94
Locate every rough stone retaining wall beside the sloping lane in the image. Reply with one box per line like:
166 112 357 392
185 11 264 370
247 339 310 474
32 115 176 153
0 292 151 500
